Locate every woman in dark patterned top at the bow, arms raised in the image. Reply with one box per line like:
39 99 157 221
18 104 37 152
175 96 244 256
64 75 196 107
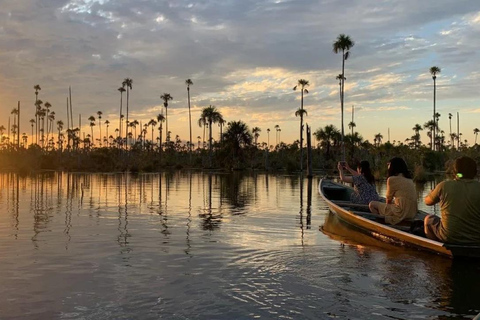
337 160 380 204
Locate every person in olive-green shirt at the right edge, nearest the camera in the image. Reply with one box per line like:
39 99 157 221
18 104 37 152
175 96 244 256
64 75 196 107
424 156 480 245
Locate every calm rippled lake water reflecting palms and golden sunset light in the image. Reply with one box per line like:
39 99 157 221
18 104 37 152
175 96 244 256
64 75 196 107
0 172 480 320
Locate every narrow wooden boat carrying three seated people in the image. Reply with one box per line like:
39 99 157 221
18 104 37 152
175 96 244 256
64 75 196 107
318 179 480 259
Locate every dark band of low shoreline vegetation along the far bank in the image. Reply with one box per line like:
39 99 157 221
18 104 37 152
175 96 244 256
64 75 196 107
0 138 480 182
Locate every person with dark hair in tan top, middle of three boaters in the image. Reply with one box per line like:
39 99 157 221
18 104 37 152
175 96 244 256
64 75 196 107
368 157 418 225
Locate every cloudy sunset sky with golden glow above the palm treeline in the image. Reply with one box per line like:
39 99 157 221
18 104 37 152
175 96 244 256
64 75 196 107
0 0 480 144
